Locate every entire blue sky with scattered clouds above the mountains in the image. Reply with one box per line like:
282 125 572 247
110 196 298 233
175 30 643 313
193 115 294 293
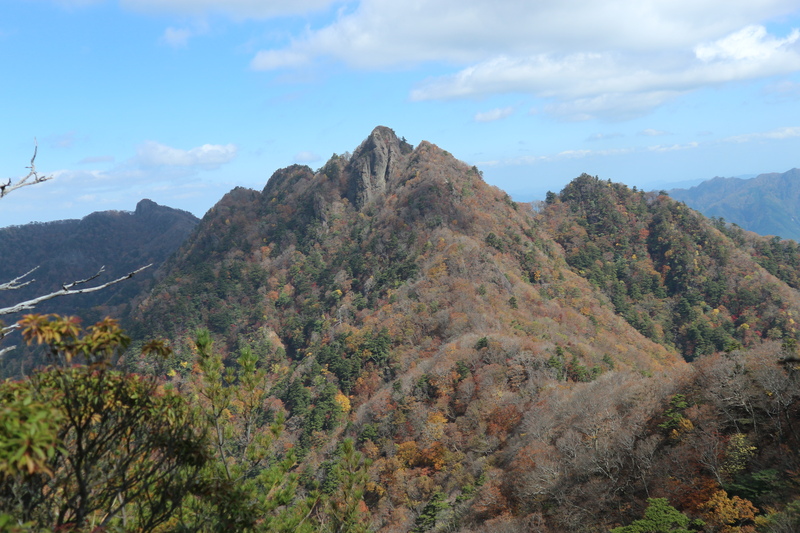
0 0 800 227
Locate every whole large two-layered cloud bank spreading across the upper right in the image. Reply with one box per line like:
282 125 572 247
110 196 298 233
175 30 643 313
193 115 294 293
245 0 800 120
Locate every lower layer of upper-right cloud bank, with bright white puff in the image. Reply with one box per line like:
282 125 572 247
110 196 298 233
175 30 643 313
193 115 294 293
411 21 800 120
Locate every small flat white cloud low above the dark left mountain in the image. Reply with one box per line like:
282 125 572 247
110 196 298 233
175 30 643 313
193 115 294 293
134 141 237 170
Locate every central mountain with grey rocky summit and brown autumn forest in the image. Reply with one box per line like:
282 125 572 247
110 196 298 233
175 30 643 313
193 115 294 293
124 128 700 531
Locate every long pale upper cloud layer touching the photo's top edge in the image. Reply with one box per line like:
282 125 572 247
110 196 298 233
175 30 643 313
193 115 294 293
252 0 797 68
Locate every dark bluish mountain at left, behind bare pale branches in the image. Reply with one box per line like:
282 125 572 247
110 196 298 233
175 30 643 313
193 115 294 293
0 200 199 321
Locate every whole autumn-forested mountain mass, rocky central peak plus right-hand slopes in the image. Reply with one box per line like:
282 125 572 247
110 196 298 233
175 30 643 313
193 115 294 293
112 127 800 532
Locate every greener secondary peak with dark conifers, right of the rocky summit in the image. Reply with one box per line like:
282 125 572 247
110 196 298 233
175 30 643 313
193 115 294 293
541 174 800 360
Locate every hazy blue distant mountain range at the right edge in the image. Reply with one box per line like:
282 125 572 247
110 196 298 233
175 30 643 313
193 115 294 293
669 168 800 241
